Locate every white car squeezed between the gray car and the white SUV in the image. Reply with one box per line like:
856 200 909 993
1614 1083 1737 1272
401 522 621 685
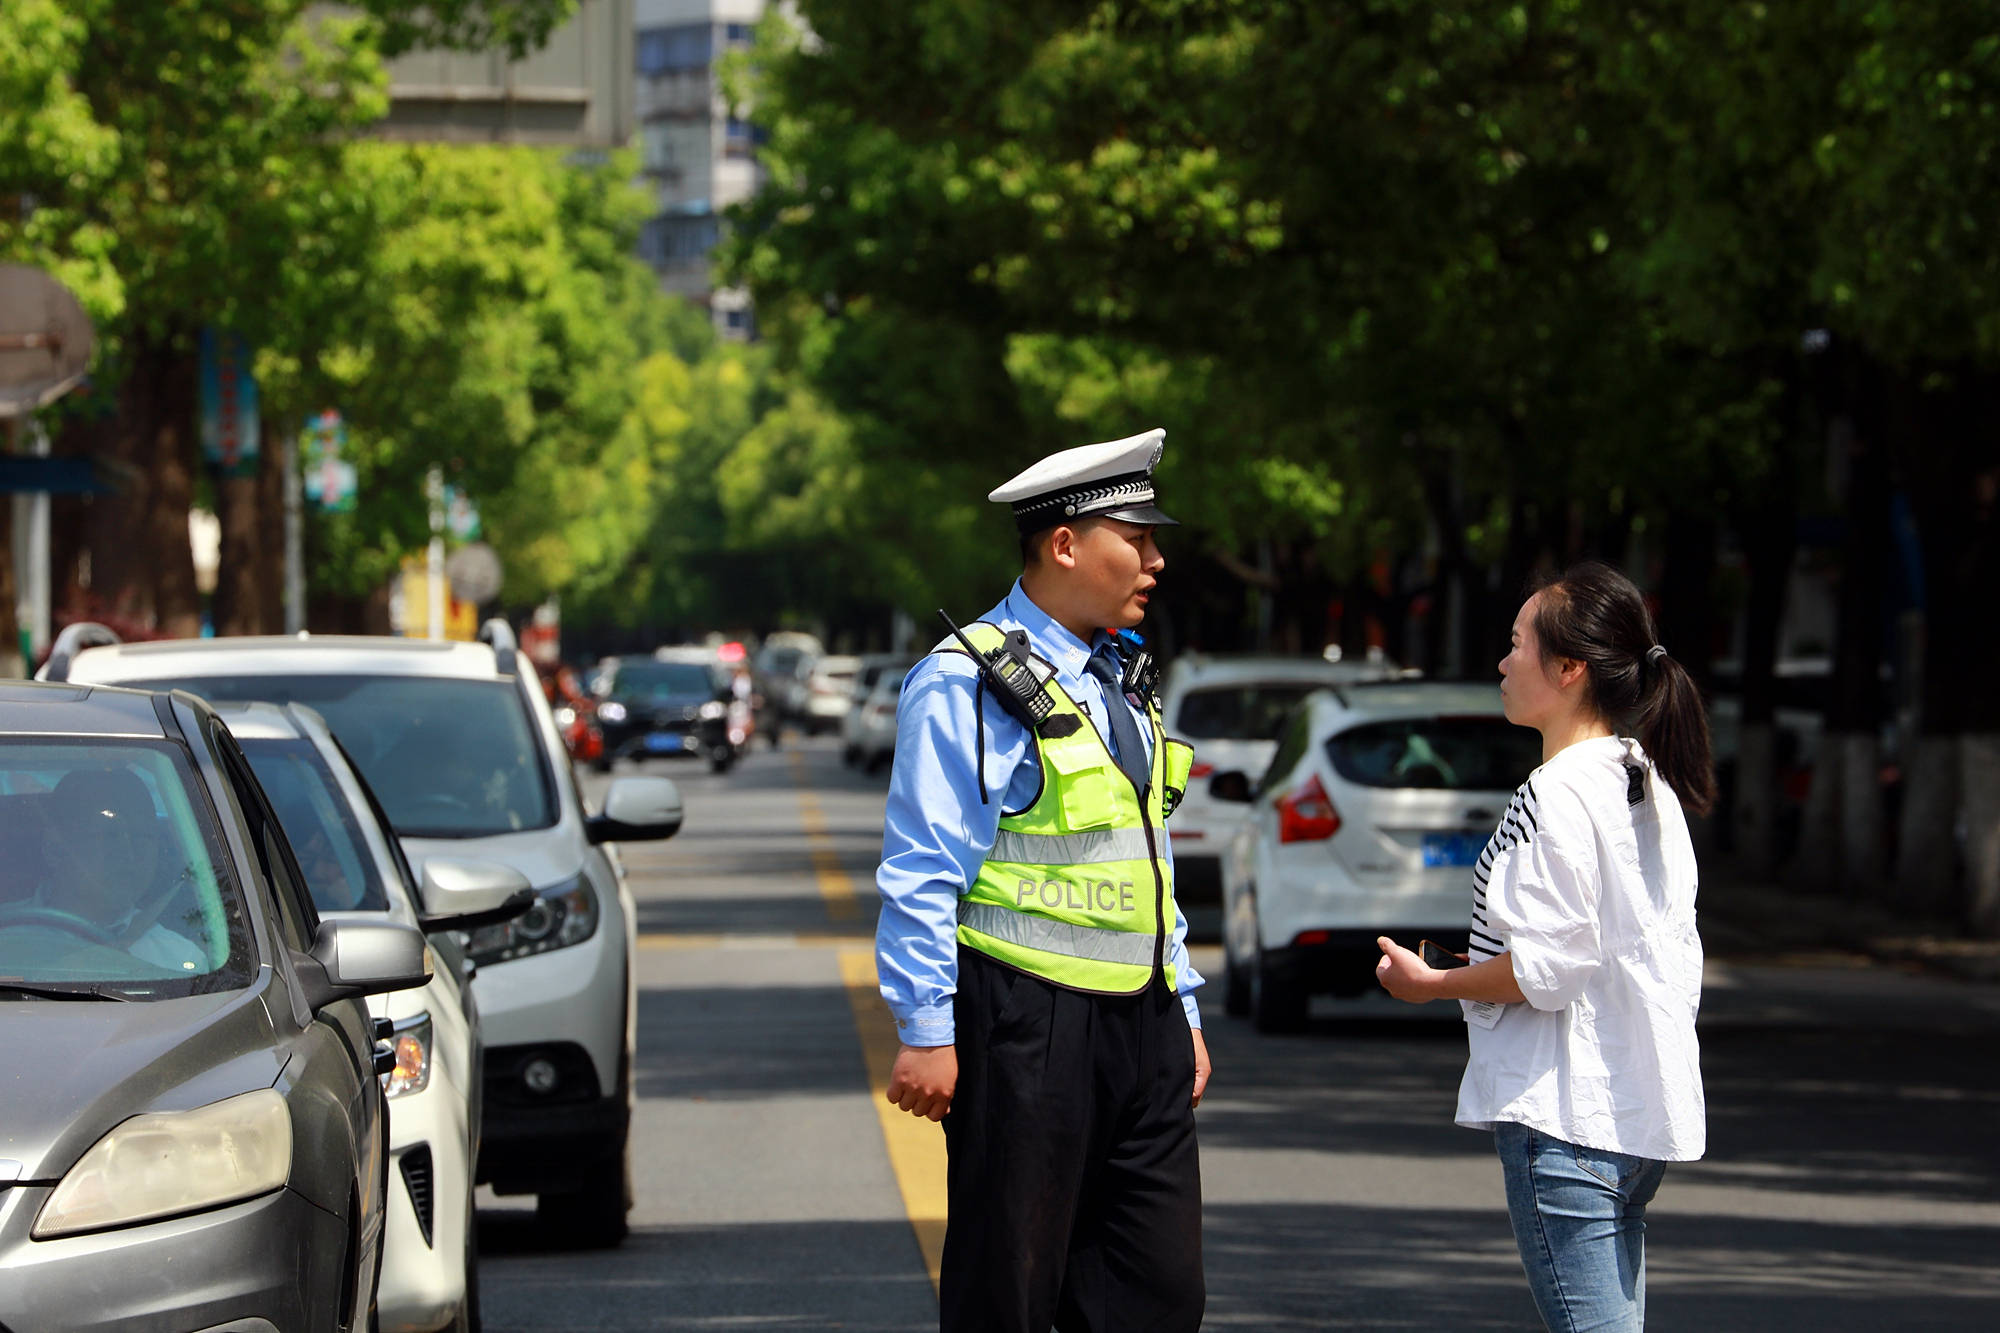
218 703 534 1333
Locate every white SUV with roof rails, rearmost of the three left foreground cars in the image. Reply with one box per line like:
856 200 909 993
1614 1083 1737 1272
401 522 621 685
42 620 682 1245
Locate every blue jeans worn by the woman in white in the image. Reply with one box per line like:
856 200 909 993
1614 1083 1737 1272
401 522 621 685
1494 1123 1666 1333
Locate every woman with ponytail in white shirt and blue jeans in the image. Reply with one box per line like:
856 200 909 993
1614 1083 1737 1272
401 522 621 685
1376 562 1714 1333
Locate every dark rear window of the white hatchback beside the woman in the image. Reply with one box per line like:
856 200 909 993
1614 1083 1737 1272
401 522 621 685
1326 717 1542 791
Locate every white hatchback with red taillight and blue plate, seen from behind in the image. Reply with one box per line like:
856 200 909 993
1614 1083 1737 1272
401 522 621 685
1200 681 1542 1031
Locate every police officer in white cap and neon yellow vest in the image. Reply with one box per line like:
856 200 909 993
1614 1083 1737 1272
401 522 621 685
876 430 1208 1333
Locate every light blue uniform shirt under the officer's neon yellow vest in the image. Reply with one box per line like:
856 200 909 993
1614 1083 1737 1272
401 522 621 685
876 580 1202 1047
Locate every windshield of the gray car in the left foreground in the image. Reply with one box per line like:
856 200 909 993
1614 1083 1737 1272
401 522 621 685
0 741 256 999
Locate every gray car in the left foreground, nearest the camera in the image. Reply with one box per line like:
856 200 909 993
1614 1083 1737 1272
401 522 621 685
0 683 428 1333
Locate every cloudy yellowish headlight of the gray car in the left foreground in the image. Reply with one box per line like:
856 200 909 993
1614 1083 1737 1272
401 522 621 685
32 1087 292 1241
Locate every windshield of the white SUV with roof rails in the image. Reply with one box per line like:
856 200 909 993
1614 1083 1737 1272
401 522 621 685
128 677 556 839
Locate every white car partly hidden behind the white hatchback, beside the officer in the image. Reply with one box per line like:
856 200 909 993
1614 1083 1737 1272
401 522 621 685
1160 652 1402 924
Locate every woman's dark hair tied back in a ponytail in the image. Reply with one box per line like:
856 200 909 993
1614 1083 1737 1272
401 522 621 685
1534 560 1716 815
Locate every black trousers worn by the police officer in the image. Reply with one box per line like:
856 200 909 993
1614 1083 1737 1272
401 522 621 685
938 949 1206 1333
